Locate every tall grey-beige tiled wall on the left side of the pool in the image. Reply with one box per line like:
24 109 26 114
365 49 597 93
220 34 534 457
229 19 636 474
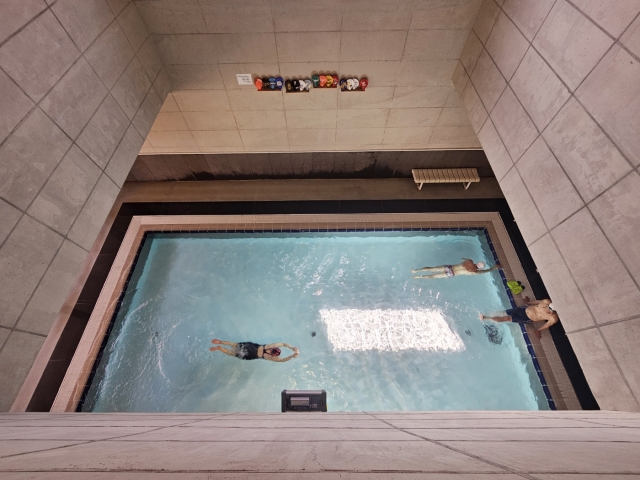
0 0 171 411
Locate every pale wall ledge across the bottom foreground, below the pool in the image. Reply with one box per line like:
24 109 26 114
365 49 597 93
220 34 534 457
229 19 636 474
0 410 640 474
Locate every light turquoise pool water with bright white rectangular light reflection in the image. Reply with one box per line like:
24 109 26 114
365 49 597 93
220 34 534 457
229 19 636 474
82 230 549 412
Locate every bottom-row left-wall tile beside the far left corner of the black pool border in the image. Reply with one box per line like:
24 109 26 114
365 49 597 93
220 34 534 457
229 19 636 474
69 174 120 250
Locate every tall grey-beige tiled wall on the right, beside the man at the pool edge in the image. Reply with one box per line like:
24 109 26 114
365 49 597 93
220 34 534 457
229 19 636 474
454 0 640 410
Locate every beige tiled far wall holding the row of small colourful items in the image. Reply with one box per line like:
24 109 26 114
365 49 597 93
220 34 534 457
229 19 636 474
135 0 481 154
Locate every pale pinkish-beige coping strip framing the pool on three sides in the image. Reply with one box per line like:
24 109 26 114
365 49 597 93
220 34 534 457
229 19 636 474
51 212 580 412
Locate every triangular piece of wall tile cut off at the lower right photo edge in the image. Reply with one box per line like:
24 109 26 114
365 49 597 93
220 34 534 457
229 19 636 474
601 318 640 398
